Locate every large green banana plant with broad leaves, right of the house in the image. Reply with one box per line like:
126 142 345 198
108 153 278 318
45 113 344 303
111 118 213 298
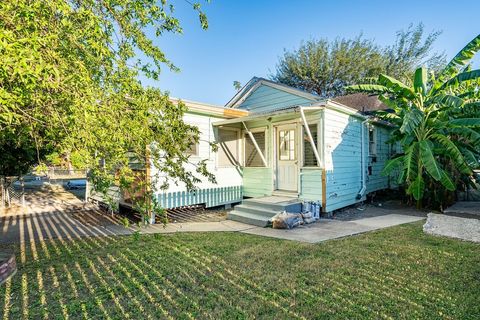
347 35 480 207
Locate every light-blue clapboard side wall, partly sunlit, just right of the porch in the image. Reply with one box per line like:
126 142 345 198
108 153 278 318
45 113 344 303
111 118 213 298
324 109 368 212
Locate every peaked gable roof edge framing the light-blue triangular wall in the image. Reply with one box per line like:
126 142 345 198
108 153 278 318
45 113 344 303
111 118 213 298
225 77 322 108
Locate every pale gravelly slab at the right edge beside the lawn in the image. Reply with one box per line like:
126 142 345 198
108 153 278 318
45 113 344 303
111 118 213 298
423 213 480 242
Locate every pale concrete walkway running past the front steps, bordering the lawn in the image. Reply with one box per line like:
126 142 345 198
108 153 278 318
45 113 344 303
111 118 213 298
140 214 425 243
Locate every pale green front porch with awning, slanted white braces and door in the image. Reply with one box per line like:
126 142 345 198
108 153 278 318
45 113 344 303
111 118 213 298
213 106 325 203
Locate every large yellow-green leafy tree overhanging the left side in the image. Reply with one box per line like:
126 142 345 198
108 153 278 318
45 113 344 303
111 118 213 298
0 0 214 218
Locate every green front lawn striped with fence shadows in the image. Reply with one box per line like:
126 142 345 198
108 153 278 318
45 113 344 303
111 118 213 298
0 223 480 319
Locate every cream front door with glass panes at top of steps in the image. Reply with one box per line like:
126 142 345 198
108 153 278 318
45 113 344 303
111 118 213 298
276 124 298 191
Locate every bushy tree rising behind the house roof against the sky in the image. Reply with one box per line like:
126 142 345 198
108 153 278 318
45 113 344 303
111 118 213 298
270 24 444 98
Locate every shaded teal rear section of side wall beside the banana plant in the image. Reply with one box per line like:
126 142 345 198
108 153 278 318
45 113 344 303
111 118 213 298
367 126 392 193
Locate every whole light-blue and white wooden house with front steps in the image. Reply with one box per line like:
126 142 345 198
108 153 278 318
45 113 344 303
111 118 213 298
90 78 393 225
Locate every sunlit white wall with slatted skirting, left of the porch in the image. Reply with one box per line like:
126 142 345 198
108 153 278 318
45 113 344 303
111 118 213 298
152 113 242 209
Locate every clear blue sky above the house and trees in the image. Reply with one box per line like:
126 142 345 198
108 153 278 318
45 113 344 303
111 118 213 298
143 0 480 105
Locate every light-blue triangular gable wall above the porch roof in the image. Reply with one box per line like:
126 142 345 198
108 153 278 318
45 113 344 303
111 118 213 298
238 85 312 112
